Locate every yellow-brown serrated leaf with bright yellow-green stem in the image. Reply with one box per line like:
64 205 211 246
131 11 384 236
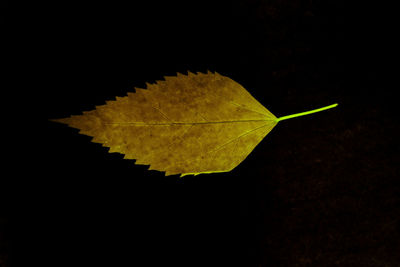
53 72 337 176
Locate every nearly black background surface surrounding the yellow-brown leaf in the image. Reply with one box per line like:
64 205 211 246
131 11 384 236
0 0 400 267
